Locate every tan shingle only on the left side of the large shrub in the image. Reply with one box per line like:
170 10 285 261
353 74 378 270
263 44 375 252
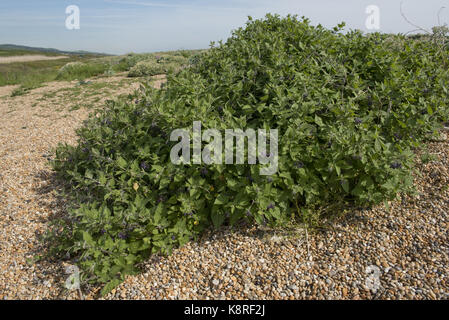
0 77 142 299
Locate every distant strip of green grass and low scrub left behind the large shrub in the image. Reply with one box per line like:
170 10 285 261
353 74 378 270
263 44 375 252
0 49 204 95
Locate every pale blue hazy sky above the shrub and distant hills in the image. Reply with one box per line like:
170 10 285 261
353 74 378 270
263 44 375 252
0 0 449 54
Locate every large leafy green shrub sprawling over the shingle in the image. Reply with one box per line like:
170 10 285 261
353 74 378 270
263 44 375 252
49 15 448 293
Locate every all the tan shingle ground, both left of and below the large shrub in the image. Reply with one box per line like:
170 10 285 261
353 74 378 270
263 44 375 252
0 76 449 299
